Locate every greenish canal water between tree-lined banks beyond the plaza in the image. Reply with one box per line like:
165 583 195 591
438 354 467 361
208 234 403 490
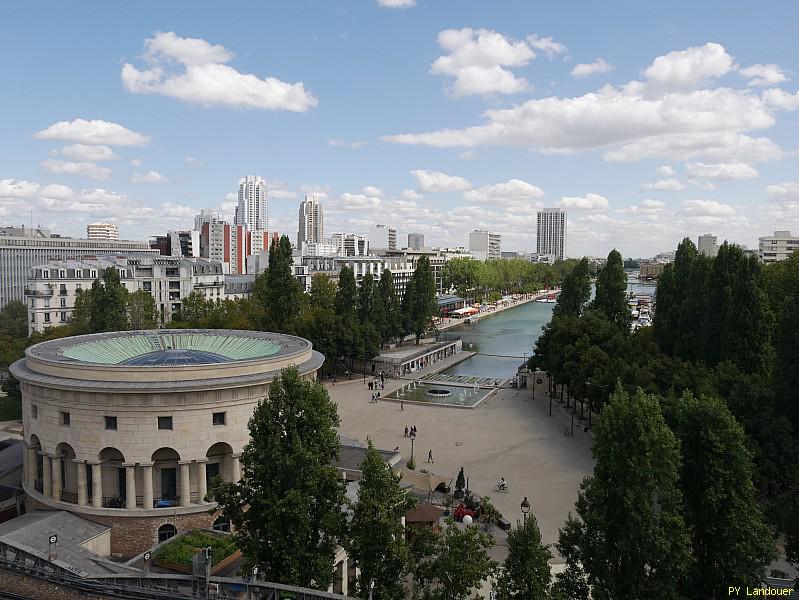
444 302 555 379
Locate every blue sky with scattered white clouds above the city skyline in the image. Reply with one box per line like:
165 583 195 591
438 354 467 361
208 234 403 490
0 0 799 257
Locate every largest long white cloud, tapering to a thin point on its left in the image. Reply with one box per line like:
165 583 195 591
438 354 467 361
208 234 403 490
383 44 780 162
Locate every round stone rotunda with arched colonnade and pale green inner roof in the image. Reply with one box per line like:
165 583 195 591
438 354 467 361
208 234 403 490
11 329 324 556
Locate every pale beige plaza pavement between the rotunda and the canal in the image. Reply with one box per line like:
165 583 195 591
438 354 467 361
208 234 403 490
327 363 593 570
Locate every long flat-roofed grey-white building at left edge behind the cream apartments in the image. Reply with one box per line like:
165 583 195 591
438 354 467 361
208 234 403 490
0 227 158 308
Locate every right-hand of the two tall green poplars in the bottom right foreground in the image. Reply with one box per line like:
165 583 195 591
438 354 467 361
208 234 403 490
672 392 775 600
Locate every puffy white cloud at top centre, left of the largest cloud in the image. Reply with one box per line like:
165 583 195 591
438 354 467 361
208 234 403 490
430 27 535 97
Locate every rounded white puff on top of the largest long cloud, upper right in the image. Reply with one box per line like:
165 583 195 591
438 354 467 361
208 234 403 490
644 43 735 90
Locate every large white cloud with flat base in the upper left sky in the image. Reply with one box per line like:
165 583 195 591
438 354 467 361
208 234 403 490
121 31 318 112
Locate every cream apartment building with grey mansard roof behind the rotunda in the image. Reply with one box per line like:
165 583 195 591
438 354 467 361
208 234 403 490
25 256 225 333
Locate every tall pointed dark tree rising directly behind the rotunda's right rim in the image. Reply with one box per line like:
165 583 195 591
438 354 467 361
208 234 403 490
253 235 303 333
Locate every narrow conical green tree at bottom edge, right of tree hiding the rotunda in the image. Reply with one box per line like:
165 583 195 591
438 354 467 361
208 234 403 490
346 440 415 600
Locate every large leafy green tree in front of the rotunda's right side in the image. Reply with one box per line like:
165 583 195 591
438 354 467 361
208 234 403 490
214 368 346 590
